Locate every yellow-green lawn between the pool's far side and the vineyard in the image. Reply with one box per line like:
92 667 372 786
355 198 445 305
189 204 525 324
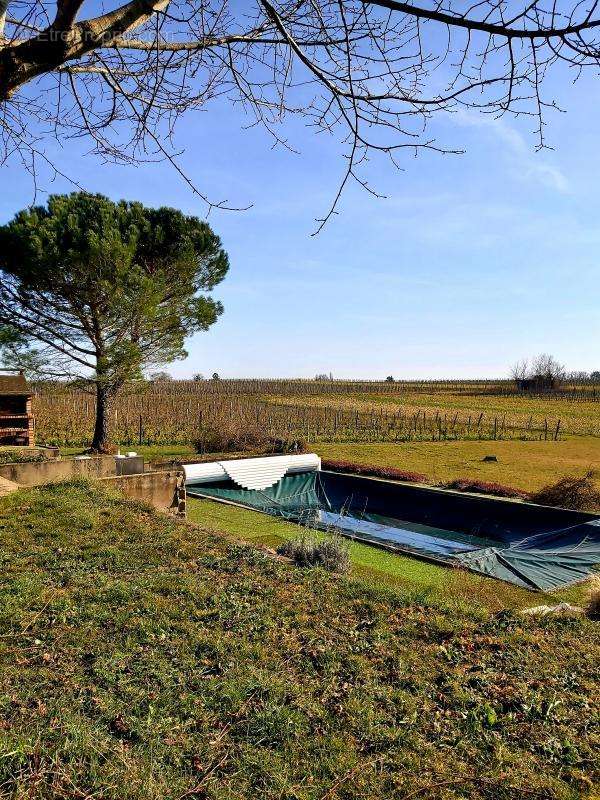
314 436 600 490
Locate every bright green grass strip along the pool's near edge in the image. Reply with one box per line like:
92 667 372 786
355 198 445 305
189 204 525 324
188 497 588 611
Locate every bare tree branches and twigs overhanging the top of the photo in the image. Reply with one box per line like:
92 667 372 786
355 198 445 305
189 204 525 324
0 0 600 225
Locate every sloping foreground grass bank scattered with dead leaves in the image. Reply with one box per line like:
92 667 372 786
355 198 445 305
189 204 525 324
0 484 599 800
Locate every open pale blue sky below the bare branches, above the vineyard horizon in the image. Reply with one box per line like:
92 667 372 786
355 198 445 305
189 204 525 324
0 57 600 378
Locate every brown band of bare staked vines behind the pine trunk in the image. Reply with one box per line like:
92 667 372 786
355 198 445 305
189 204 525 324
36 393 565 446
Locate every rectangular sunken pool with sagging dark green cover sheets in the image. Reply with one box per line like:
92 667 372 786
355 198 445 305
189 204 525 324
187 471 600 590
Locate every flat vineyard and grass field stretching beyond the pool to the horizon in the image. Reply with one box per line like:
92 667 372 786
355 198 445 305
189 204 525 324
35 380 600 490
